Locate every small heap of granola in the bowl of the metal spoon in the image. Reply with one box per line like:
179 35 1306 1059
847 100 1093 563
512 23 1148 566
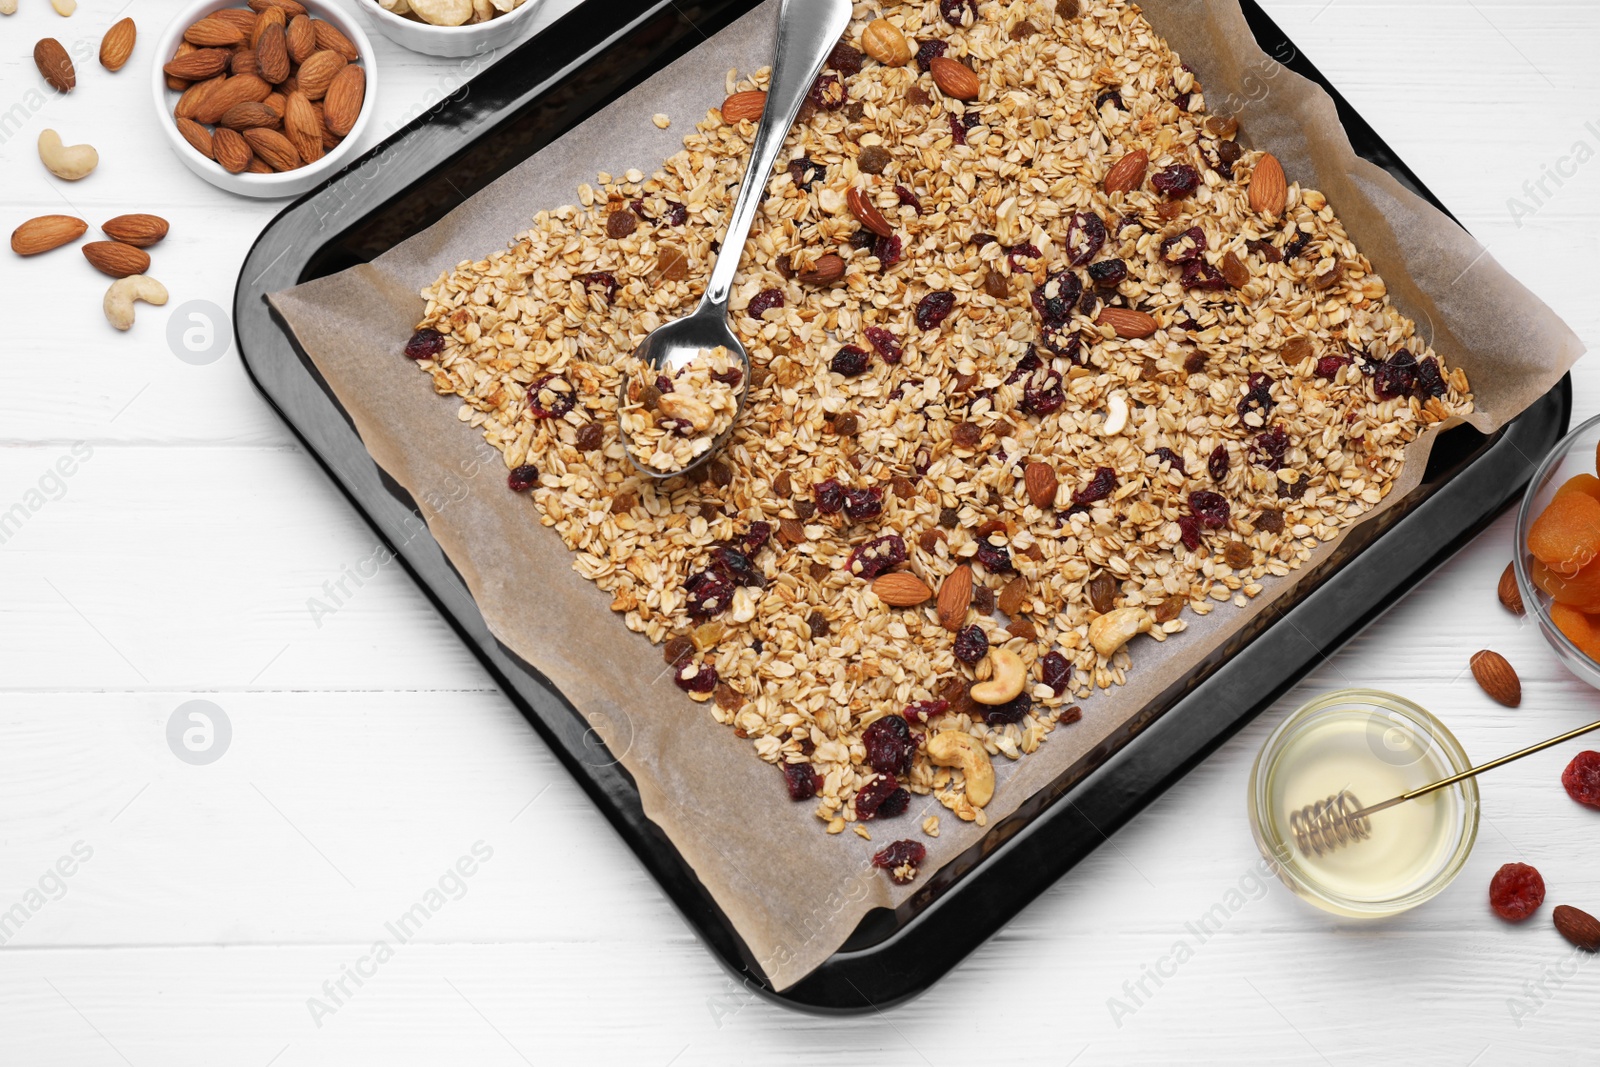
618 346 744 472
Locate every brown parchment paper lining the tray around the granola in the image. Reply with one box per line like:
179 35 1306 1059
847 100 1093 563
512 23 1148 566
270 0 1582 989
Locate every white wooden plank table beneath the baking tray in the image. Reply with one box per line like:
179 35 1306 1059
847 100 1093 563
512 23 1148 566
0 0 1600 1067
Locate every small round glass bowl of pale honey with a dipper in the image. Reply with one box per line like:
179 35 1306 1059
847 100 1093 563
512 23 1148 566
1250 689 1478 918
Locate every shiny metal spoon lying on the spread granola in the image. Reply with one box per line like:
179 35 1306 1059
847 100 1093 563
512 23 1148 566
622 0 851 478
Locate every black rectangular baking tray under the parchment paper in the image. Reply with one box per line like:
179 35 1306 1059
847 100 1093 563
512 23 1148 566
234 0 1571 1013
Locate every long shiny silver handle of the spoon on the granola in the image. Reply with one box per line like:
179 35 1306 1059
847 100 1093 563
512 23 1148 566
699 0 851 315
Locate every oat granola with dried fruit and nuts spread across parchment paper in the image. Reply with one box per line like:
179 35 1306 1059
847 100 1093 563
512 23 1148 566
408 0 1472 844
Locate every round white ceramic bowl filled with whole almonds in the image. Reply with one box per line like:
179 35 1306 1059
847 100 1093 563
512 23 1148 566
150 0 378 197
